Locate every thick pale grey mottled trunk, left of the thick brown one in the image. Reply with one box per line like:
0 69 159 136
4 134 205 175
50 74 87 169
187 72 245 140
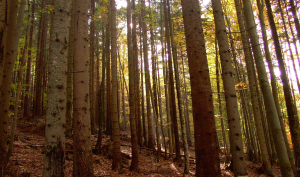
43 0 70 176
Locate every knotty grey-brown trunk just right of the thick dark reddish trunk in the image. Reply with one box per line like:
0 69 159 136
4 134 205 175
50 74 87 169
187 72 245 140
212 0 247 176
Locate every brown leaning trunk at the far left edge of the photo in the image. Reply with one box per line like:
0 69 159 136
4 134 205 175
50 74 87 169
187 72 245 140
0 0 23 176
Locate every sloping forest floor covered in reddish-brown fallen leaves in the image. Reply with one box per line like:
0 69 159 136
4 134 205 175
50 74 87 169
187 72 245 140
6 119 281 177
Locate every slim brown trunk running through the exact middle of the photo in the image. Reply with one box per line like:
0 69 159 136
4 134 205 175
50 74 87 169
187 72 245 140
141 0 154 149
